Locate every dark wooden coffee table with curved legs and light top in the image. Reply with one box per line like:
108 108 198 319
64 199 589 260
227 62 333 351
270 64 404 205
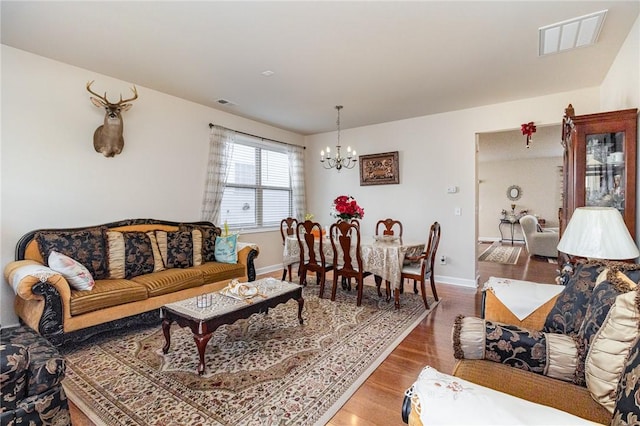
160 278 304 374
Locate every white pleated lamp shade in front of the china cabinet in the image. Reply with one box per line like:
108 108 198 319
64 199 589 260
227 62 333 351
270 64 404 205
558 207 639 260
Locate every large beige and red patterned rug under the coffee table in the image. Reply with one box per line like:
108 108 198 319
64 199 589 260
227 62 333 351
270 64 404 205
63 285 437 425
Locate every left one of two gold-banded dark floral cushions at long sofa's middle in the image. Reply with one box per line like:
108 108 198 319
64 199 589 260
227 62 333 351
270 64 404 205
107 231 164 278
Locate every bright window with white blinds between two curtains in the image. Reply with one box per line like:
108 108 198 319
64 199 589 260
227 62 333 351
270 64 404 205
220 134 292 229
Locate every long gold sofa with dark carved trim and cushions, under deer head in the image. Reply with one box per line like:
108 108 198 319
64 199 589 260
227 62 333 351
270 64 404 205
4 219 258 345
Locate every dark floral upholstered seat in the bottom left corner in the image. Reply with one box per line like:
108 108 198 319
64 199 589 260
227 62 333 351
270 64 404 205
0 326 71 426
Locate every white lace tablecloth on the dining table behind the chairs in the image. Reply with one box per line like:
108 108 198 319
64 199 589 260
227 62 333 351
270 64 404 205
282 236 424 289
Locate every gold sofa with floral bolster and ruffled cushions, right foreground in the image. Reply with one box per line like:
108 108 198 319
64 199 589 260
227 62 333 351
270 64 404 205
403 261 640 425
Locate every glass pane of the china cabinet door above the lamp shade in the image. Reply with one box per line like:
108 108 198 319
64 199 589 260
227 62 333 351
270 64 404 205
584 132 626 217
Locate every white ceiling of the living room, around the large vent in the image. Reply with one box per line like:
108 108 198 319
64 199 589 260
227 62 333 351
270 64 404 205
0 0 640 134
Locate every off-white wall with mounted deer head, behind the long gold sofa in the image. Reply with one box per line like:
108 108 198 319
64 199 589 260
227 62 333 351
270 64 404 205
0 45 304 326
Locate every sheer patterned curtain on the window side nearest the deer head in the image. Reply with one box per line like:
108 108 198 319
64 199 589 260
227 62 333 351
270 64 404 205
201 126 236 226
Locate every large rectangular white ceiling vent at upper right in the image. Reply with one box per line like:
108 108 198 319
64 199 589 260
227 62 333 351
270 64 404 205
538 10 607 56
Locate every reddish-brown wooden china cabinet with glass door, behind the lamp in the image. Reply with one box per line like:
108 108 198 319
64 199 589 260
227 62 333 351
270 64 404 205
560 104 638 239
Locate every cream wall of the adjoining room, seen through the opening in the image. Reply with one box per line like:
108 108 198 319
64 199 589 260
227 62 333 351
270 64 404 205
478 156 562 241
